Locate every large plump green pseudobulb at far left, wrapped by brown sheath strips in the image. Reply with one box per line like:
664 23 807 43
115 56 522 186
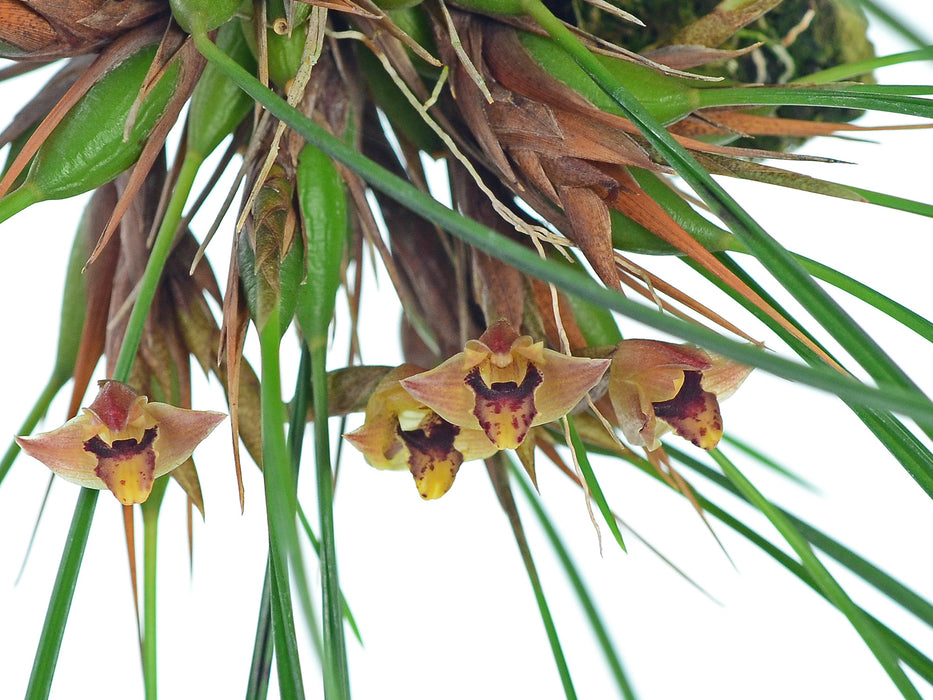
0 47 180 221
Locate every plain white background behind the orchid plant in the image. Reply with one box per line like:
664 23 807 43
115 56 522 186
0 2 933 700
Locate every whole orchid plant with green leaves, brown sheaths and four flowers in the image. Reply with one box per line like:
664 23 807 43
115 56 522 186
0 0 933 700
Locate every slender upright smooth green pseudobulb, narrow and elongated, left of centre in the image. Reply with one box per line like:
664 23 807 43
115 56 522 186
295 144 349 346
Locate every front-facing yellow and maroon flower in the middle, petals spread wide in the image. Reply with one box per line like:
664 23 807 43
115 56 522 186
402 321 609 449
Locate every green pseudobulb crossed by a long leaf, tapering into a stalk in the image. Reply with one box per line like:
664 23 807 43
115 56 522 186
188 22 256 158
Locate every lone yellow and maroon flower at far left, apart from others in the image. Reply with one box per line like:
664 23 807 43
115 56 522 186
16 380 225 505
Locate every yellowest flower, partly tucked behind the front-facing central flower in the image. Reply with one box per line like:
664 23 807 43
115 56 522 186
344 365 498 500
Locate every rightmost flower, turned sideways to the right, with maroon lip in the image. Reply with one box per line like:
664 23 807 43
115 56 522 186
609 340 750 450
